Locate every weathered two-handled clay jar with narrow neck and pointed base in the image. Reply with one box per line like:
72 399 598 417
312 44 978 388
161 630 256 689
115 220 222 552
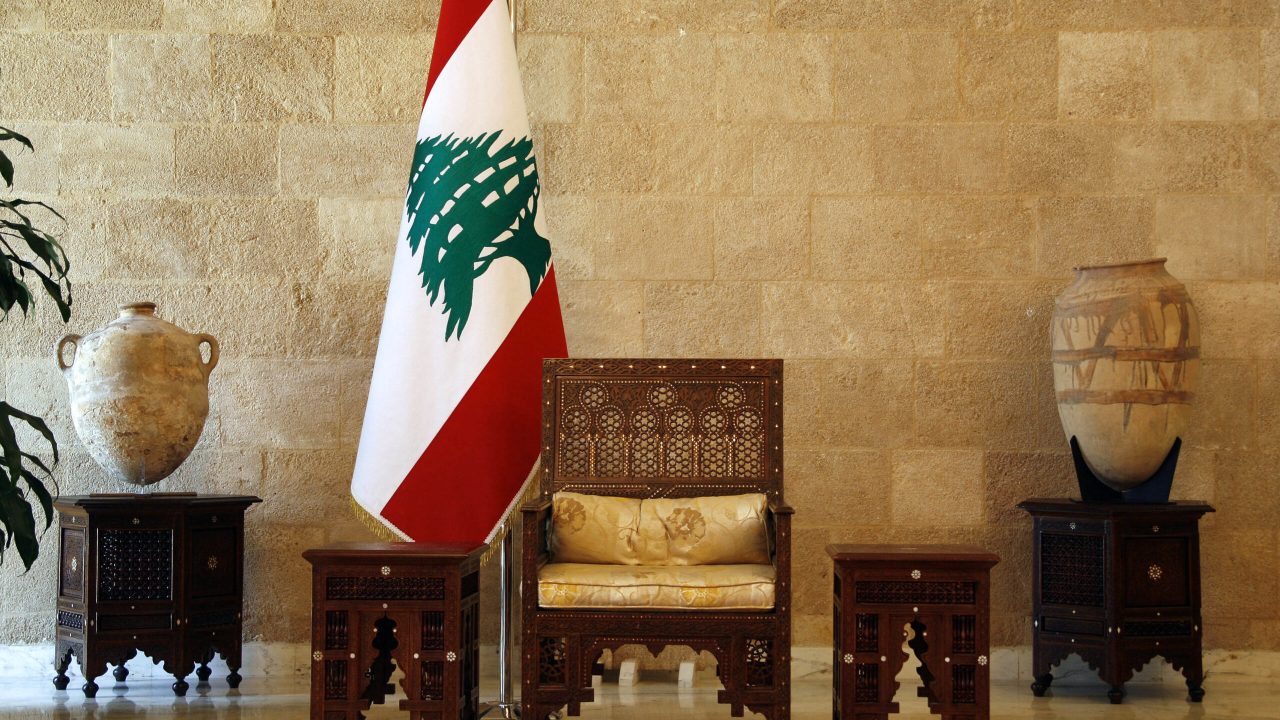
56 302 218 486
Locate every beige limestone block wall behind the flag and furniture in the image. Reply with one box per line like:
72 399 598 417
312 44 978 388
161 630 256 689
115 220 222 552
0 0 1280 650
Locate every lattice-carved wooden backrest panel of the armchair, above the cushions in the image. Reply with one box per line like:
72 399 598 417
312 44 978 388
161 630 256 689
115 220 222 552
544 360 782 495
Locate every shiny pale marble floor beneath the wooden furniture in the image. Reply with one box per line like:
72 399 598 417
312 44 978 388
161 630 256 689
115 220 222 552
0 673 1280 720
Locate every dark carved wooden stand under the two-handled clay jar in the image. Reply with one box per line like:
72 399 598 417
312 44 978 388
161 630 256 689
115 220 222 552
54 493 261 697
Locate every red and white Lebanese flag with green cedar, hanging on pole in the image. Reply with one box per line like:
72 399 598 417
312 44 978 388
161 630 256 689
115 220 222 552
351 0 566 542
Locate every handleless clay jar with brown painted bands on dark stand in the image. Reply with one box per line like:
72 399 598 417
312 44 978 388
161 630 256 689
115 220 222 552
1052 258 1199 492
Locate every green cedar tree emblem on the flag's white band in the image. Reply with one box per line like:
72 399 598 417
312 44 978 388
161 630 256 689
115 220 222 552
404 132 552 341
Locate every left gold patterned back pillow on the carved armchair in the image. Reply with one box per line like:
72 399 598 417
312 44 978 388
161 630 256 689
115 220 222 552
552 492 641 565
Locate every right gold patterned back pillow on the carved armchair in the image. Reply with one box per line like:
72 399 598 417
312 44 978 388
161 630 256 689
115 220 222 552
640 493 769 565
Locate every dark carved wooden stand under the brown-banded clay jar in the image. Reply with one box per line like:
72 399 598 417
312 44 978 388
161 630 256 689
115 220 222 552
1018 500 1213 703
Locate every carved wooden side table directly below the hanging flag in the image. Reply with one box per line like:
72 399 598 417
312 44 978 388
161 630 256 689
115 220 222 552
302 543 484 720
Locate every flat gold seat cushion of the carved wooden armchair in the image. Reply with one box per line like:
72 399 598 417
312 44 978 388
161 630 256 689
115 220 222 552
538 562 774 610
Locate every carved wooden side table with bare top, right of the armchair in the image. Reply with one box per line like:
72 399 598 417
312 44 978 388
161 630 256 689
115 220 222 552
827 544 1000 720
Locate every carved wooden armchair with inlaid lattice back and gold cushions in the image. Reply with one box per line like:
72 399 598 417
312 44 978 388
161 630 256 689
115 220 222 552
521 359 791 720
